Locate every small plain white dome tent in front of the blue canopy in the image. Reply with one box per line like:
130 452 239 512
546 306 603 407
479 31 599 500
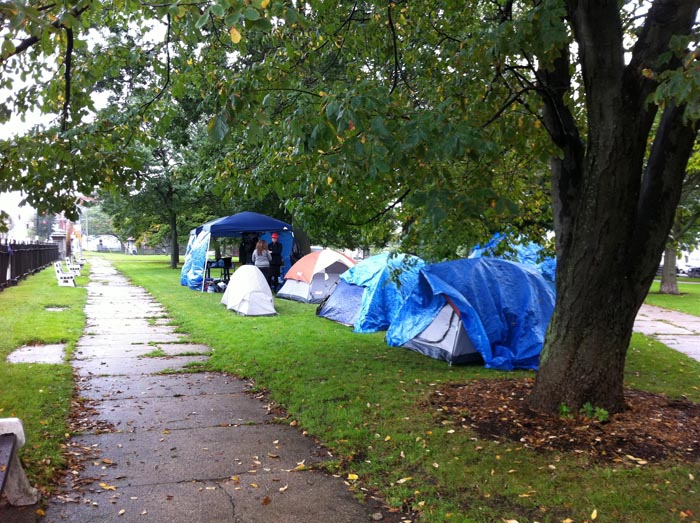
221 265 277 316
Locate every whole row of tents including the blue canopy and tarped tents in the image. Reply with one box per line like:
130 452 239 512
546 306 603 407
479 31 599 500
181 212 555 370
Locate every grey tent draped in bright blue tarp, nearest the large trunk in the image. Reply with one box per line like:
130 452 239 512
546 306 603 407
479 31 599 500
386 258 554 370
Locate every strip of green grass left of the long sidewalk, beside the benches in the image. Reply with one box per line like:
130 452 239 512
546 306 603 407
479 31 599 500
0 267 87 488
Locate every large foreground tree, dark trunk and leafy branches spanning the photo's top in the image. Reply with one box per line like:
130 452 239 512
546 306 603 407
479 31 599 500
0 0 700 412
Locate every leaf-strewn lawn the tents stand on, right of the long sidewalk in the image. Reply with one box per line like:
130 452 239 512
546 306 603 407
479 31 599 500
102 256 700 523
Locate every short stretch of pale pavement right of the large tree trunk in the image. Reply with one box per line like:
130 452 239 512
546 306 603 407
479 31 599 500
634 304 700 361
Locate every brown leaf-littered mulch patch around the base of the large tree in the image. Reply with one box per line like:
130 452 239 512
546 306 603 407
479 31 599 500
429 378 700 464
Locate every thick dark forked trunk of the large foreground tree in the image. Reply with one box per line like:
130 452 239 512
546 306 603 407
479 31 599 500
529 0 700 413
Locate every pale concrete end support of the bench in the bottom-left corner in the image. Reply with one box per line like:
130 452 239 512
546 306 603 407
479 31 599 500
0 418 41 506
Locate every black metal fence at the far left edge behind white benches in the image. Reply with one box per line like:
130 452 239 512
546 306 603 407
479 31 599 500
0 241 59 291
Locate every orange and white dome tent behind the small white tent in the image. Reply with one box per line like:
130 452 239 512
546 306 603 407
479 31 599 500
277 249 355 303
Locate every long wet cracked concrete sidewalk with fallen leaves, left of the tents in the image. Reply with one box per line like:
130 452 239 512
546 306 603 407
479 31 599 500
9 258 399 523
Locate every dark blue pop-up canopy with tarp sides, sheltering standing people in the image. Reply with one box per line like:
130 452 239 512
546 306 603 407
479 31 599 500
180 211 294 290
